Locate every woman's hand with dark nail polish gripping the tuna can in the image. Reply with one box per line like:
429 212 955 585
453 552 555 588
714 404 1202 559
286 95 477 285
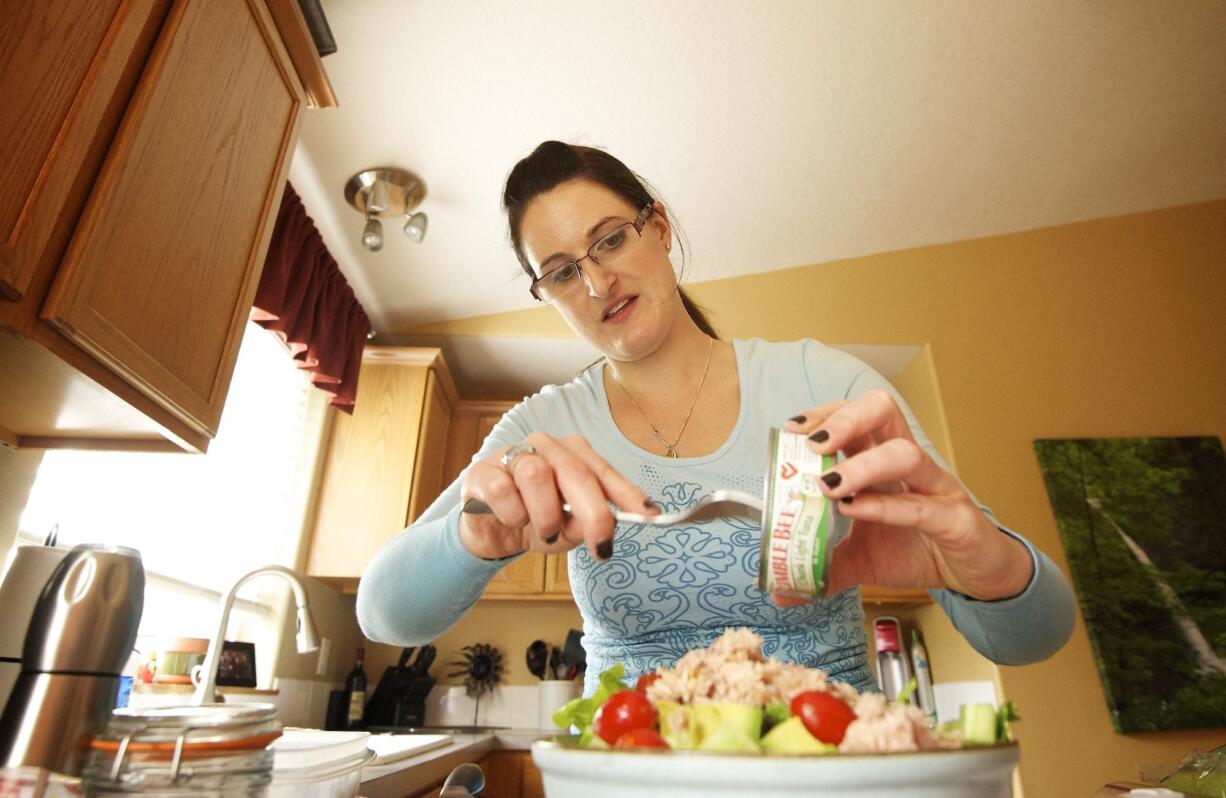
781 390 1034 603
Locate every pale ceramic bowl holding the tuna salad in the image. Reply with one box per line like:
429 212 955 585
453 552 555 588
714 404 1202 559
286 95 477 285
532 738 1018 798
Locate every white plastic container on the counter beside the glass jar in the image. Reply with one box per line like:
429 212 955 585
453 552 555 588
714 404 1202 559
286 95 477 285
268 728 375 798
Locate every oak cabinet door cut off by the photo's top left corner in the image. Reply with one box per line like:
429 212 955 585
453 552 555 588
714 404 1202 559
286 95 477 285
0 0 169 302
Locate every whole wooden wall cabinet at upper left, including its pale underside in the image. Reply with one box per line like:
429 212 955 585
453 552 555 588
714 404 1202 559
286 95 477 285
0 0 335 451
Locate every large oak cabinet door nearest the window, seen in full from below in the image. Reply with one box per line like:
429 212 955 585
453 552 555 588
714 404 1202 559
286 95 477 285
40 0 304 435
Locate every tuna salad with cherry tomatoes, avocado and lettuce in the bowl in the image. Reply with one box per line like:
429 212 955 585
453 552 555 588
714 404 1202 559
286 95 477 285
553 629 1019 754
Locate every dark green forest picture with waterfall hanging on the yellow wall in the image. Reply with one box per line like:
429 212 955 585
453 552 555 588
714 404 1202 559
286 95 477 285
1035 438 1226 733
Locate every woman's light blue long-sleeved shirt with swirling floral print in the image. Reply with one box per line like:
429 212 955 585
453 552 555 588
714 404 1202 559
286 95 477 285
357 340 1075 693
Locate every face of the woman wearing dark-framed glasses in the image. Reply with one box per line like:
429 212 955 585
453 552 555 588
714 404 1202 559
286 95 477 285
520 179 684 360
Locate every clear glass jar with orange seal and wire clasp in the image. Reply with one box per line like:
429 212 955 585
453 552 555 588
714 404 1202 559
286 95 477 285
81 704 281 798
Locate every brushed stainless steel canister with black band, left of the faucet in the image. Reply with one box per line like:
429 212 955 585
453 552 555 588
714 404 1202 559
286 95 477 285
0 543 145 776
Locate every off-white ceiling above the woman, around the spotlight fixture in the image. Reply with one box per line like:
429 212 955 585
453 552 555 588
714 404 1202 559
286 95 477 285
291 0 1226 390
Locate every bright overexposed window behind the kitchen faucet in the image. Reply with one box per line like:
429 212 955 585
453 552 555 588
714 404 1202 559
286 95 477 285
18 324 327 685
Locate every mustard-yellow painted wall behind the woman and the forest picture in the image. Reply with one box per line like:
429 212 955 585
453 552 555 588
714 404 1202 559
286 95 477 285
414 200 1226 798
